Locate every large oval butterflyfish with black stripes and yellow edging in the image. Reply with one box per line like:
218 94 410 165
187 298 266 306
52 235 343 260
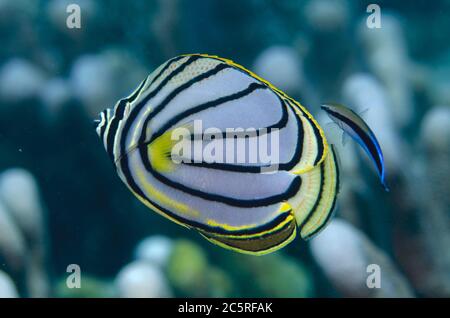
96 54 339 255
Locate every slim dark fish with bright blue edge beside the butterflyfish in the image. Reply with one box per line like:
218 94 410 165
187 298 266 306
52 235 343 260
321 104 389 191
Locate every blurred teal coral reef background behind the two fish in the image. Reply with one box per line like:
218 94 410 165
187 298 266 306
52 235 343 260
0 0 450 297
